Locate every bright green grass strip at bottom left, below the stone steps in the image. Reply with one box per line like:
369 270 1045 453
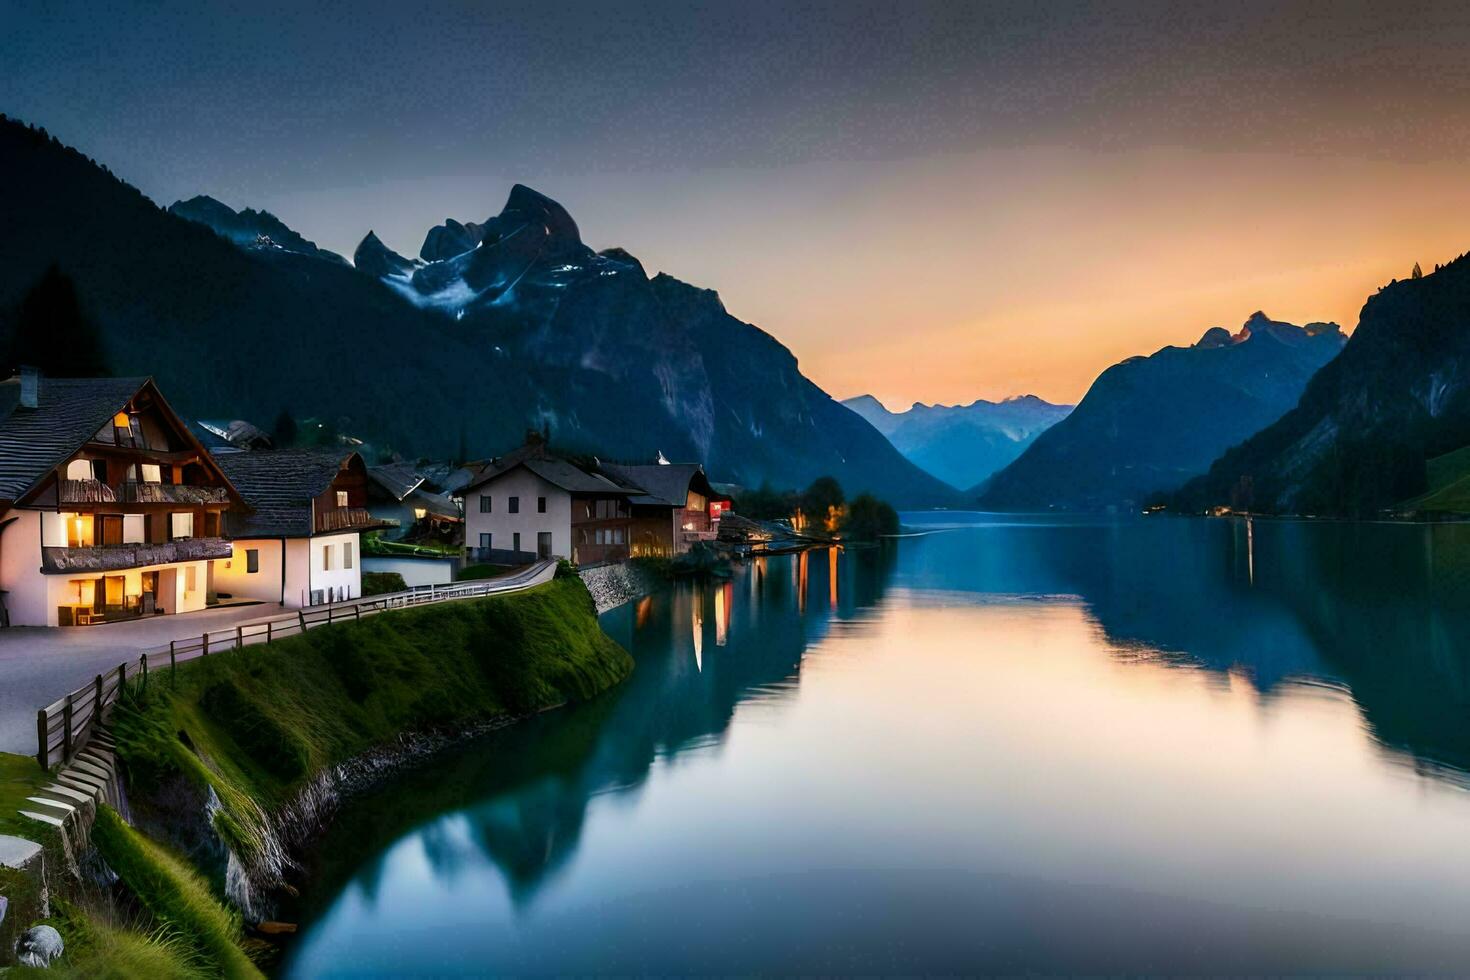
93 807 262 979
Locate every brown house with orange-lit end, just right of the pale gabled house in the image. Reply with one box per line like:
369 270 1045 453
603 461 732 558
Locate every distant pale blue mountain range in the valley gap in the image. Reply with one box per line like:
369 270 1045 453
842 395 1072 489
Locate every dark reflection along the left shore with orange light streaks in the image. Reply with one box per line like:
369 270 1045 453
285 550 894 917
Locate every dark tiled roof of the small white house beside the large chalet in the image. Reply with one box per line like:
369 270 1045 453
215 450 353 538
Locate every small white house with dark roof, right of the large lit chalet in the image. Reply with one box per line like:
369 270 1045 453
215 450 392 608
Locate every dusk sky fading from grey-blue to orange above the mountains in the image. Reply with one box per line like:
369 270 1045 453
0 0 1470 408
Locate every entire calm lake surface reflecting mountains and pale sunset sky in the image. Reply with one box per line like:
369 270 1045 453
285 514 1470 977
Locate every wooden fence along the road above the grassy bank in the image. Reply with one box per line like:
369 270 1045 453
35 561 556 768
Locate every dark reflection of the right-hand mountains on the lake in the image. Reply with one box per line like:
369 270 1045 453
895 516 1470 779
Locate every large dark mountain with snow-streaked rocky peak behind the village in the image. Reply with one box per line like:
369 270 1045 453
0 118 953 505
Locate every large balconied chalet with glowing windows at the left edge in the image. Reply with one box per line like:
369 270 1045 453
0 370 243 626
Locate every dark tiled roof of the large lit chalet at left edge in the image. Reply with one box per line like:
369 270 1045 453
0 378 148 501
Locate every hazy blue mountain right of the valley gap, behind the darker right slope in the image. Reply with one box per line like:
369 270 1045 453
976 313 1347 510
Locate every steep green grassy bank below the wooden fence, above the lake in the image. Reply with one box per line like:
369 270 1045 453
113 576 632 860
